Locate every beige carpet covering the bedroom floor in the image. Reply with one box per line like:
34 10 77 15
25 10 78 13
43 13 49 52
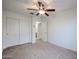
3 42 77 59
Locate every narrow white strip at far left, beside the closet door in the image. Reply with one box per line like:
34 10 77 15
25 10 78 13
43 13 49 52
2 12 7 49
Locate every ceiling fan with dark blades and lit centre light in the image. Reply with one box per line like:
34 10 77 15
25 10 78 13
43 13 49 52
27 1 55 16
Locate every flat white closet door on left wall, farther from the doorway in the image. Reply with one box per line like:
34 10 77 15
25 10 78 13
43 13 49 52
6 18 19 46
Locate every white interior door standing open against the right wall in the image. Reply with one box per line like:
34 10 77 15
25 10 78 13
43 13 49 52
38 22 47 41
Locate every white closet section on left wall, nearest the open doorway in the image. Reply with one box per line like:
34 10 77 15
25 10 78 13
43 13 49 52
20 17 31 44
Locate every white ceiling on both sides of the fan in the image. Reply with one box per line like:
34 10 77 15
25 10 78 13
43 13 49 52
2 0 77 13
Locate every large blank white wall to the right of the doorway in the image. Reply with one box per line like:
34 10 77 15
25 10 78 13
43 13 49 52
48 8 77 51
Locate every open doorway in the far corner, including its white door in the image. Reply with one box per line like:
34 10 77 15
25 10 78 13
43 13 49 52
32 21 47 42
